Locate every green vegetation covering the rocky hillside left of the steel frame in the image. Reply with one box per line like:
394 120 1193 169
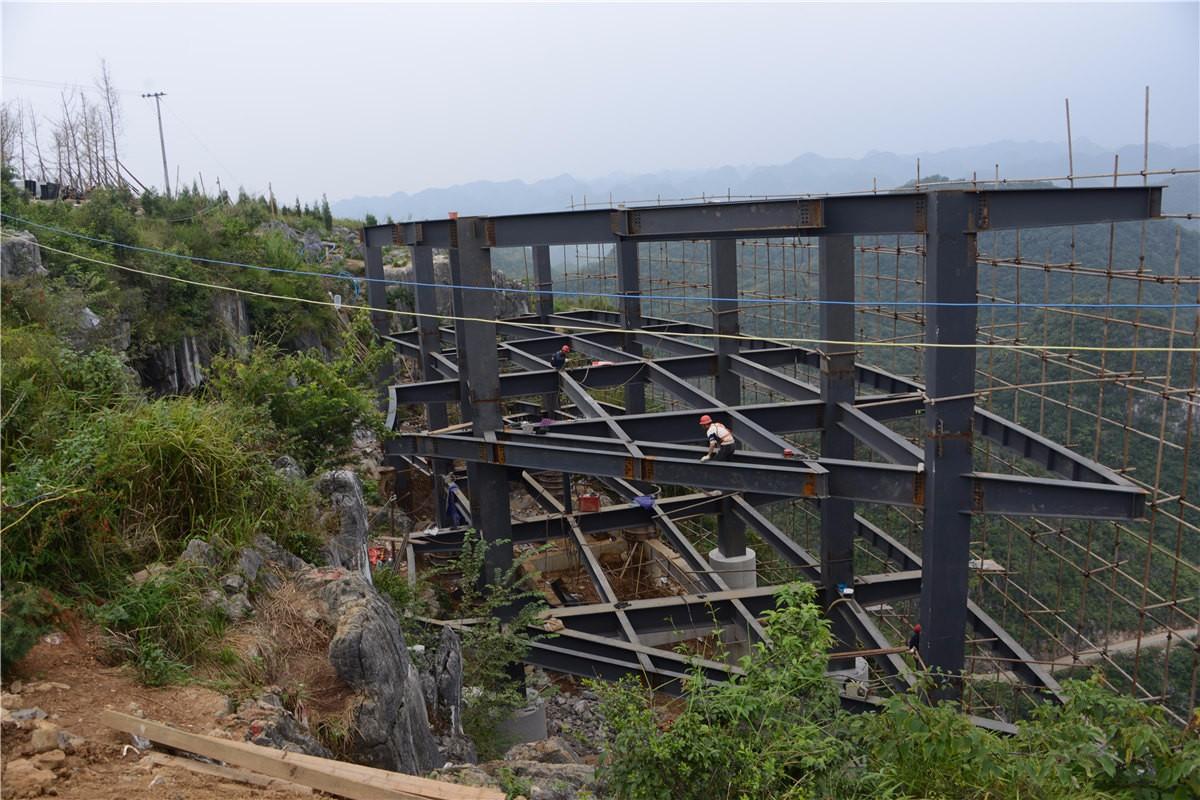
0 187 388 685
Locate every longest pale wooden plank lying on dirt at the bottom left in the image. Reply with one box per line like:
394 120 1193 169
101 711 504 800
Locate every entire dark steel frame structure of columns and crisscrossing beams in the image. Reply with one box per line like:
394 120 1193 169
362 187 1162 714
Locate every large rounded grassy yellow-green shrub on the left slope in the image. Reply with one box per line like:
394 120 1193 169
0 398 308 594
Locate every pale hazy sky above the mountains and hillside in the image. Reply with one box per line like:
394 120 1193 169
2 1 1200 200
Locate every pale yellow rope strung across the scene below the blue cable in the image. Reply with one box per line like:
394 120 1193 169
18 243 1200 353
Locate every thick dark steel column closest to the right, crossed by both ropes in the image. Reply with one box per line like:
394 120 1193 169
920 192 978 696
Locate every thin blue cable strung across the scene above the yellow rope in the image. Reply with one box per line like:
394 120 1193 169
0 212 1200 309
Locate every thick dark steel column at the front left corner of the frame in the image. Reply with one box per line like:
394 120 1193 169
451 217 512 583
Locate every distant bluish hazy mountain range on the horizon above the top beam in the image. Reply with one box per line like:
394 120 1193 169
332 139 1200 222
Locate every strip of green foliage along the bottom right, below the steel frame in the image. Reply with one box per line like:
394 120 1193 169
594 584 1200 800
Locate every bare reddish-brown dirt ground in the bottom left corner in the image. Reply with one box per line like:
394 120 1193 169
0 632 298 800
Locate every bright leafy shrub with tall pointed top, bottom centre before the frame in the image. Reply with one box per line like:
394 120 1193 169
593 584 848 800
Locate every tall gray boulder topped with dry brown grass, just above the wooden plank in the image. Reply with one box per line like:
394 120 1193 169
296 567 442 775
